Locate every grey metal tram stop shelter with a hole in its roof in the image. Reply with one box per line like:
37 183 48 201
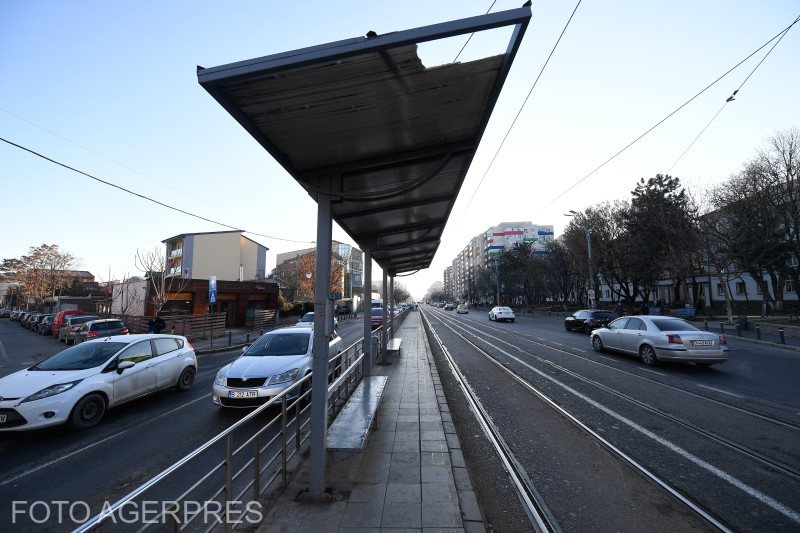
197 2 531 494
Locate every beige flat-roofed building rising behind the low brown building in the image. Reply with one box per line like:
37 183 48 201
162 230 268 281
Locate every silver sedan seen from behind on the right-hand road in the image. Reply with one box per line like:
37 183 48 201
592 315 730 366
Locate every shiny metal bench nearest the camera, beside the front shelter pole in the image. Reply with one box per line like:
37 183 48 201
328 376 389 464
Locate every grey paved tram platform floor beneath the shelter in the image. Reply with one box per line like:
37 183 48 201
257 312 485 533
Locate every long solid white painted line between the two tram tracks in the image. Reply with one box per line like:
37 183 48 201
484 341 800 523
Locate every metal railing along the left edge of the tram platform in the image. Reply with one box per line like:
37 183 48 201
75 310 408 533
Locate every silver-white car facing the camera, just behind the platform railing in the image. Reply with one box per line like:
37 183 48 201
211 327 342 407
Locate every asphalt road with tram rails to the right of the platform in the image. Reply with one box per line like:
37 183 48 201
423 306 800 531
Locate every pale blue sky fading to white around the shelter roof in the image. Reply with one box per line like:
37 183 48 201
0 0 800 299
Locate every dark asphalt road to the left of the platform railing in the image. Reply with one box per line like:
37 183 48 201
0 319 363 532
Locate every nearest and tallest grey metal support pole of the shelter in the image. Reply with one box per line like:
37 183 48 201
309 194 332 495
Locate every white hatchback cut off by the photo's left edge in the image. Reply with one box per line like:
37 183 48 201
0 335 197 431
